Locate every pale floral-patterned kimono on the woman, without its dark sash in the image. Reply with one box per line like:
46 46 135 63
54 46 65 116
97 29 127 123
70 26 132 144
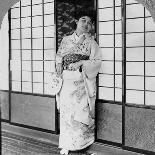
56 33 101 150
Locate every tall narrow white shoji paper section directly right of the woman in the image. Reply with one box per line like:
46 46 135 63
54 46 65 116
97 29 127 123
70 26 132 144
98 0 122 102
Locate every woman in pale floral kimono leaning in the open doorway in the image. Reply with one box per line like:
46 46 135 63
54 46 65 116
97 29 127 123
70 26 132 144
56 12 101 155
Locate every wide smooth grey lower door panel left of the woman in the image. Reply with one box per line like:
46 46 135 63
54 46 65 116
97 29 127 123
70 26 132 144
11 93 56 131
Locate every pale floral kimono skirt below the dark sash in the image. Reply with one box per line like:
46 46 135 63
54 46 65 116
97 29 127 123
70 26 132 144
59 70 94 150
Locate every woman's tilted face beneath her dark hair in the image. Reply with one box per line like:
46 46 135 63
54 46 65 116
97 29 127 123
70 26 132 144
77 16 92 33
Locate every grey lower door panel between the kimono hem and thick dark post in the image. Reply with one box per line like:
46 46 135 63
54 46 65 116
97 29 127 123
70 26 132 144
96 103 122 143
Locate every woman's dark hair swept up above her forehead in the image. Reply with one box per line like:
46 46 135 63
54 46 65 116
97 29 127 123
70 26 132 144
74 9 96 23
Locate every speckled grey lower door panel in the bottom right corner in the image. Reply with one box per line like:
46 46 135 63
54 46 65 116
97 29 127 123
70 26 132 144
125 107 155 151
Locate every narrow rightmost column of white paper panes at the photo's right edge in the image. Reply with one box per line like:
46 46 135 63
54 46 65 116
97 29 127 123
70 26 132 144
145 7 155 106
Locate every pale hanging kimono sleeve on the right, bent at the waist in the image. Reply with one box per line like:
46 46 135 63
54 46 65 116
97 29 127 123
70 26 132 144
83 40 101 79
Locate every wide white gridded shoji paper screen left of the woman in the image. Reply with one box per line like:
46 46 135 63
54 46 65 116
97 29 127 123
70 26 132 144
11 0 56 94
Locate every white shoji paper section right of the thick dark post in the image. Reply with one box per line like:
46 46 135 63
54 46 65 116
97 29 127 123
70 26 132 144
126 0 155 105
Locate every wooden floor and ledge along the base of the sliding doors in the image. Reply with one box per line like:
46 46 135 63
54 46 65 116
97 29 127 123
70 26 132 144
2 123 142 155
